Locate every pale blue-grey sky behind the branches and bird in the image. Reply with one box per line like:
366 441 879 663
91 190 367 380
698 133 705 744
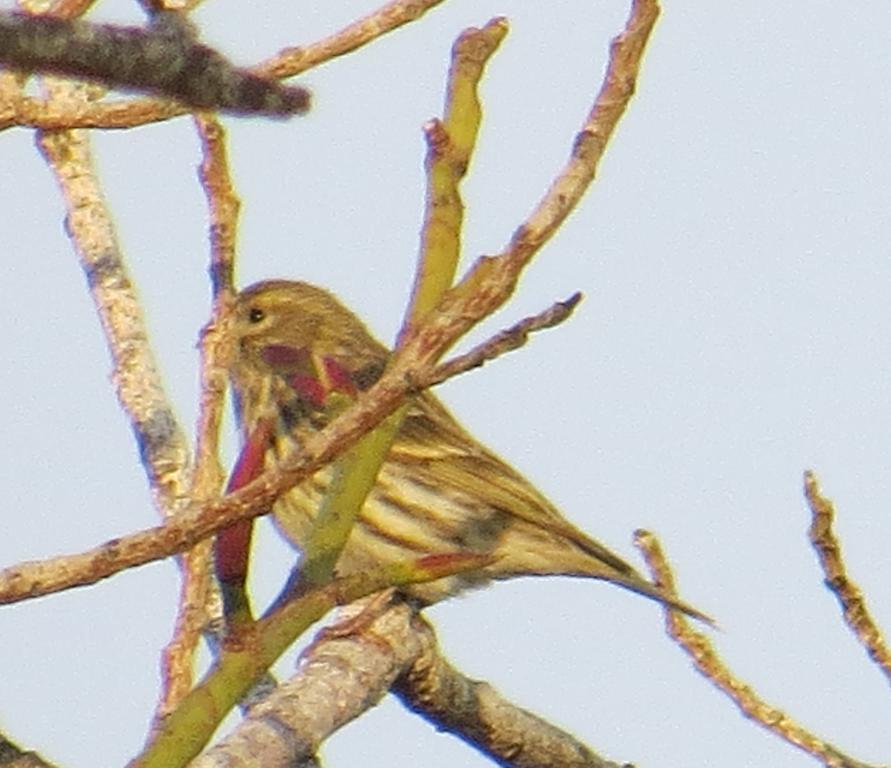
0 0 891 768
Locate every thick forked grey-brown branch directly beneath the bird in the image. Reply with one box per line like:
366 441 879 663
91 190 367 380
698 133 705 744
190 600 632 768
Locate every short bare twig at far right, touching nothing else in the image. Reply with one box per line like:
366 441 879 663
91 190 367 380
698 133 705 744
804 471 891 682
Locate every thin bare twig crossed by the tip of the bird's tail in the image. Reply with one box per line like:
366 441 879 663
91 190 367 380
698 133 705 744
634 531 871 768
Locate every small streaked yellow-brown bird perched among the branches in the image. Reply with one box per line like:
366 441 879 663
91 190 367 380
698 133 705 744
217 280 708 620
